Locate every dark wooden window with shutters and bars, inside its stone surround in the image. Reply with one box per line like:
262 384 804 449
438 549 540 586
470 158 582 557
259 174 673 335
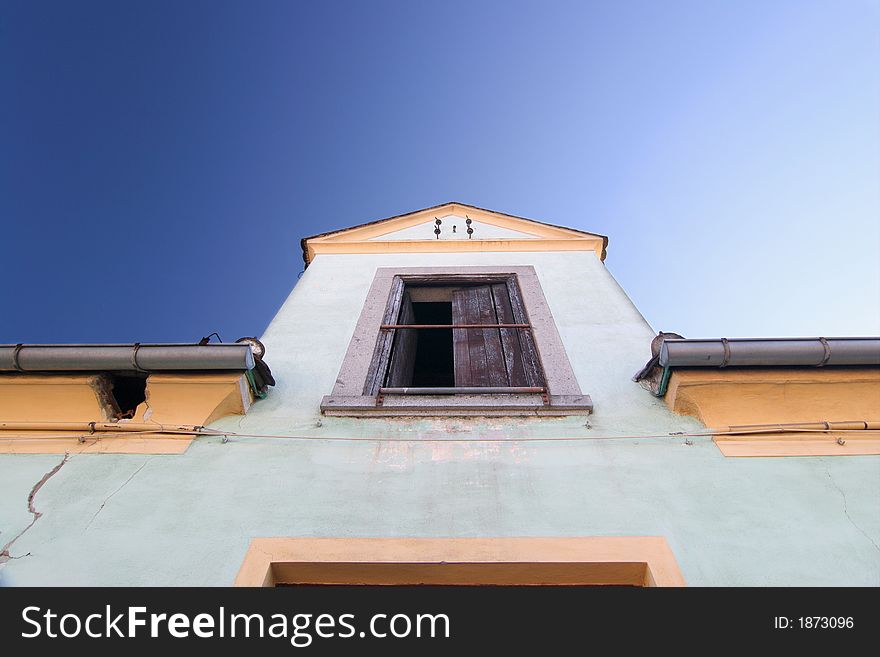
364 275 545 395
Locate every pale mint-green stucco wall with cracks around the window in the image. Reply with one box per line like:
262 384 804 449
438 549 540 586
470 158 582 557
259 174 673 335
0 252 880 585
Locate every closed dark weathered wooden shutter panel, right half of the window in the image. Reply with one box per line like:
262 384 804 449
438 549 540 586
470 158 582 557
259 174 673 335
452 283 544 387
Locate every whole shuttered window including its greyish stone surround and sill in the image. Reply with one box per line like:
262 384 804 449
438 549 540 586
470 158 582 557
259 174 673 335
321 265 592 417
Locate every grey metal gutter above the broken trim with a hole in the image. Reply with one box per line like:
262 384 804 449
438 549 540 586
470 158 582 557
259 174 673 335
0 343 254 372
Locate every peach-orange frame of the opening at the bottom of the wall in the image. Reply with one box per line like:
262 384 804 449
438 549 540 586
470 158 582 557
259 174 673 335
235 536 686 586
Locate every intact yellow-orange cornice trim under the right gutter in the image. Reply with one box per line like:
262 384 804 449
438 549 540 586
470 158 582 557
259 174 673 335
665 368 880 457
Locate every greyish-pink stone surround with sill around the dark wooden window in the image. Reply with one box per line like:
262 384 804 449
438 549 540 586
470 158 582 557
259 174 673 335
321 265 593 417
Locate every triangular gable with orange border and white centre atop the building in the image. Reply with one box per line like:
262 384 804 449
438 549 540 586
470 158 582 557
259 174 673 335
302 202 608 266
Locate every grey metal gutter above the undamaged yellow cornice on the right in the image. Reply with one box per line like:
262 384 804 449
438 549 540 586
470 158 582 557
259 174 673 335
659 337 880 368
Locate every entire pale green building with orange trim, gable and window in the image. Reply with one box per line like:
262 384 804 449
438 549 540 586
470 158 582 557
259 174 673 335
0 203 880 586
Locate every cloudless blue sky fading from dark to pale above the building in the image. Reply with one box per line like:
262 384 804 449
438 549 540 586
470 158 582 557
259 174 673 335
0 0 880 352
